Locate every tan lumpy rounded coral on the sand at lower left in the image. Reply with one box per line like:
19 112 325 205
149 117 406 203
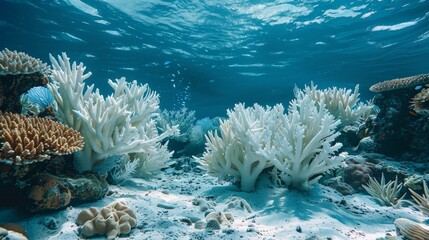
76 201 137 239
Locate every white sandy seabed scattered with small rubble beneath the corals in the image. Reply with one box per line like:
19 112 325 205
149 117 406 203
0 169 425 240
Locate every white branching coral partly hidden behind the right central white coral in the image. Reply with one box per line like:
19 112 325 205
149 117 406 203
294 82 374 129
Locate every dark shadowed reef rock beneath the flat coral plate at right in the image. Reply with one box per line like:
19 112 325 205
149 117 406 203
367 89 429 162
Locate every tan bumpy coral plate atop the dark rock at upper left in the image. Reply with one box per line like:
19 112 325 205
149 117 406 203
0 48 49 75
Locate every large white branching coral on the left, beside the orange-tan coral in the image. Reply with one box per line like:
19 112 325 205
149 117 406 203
49 53 177 171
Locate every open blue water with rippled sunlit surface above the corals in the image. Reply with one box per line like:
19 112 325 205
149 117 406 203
0 0 429 118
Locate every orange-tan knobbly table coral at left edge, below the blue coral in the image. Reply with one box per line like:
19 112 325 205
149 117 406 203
0 113 83 164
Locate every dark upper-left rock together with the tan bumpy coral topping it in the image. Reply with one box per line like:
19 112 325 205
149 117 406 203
0 48 50 113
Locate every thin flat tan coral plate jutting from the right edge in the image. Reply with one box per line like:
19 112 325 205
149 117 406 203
369 74 429 92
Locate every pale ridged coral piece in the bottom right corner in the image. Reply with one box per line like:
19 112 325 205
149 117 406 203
394 218 429 240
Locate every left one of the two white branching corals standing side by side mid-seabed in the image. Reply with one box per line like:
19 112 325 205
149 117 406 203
198 104 276 192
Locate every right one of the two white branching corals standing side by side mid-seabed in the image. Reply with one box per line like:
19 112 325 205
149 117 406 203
264 96 346 190
